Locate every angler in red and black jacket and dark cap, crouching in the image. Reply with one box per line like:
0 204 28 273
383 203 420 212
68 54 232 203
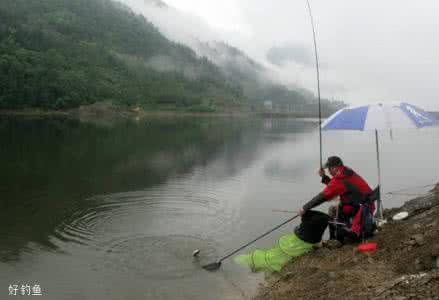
300 156 376 242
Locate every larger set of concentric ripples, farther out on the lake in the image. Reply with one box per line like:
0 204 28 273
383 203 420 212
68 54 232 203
53 183 239 247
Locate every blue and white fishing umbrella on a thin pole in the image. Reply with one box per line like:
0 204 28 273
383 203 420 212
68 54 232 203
322 102 439 217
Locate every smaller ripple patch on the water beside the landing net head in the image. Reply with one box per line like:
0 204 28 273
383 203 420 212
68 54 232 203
101 235 217 280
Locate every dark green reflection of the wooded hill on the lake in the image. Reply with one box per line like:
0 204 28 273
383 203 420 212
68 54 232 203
0 119 264 260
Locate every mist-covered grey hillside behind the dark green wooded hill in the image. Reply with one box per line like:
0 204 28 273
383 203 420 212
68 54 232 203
120 0 344 114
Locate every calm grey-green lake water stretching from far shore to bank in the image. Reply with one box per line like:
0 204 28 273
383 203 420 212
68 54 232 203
0 117 439 300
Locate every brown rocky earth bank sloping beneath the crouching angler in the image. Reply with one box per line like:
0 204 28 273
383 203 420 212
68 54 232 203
255 185 439 300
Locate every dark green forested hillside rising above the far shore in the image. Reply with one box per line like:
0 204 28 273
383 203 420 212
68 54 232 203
0 0 245 110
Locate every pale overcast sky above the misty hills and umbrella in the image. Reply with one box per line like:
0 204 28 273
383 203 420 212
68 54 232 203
127 0 439 110
